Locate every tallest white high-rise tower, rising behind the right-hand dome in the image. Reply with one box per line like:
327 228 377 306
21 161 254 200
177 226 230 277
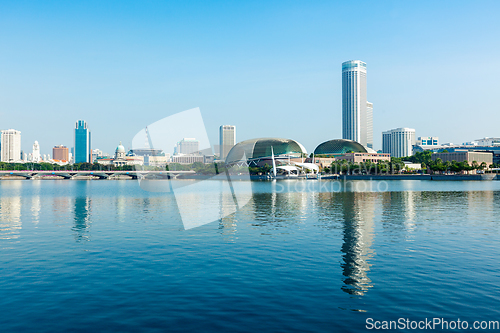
342 60 373 148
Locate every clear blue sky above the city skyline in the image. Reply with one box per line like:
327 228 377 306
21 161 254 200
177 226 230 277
0 1 500 154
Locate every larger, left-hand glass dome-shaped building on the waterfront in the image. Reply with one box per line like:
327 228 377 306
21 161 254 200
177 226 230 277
226 138 307 166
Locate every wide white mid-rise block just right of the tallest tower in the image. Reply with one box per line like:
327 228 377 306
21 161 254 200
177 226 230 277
382 128 415 157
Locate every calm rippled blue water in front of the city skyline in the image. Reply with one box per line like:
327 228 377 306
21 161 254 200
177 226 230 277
0 181 500 332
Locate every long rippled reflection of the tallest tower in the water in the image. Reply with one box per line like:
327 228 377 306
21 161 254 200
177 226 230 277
332 192 377 296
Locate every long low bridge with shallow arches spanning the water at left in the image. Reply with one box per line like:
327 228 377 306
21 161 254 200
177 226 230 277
0 170 195 179
